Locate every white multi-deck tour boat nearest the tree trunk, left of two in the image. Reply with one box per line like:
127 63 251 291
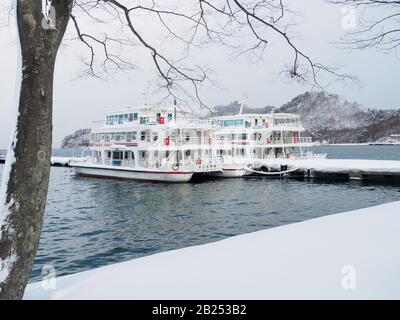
70 106 222 182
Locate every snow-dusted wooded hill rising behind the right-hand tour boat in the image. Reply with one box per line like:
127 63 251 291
214 92 400 143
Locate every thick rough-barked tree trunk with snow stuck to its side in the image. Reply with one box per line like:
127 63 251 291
0 0 73 299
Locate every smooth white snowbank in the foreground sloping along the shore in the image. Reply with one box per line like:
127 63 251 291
25 202 400 299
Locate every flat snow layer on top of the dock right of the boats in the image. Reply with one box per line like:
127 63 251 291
264 158 400 173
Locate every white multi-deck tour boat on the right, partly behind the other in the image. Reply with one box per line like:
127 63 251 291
212 112 318 177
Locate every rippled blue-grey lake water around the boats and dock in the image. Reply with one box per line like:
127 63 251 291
0 146 400 281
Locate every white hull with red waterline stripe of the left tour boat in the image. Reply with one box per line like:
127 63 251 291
74 166 193 183
